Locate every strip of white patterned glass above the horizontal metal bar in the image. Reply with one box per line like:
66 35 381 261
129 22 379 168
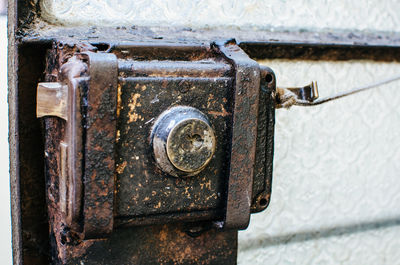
41 0 400 31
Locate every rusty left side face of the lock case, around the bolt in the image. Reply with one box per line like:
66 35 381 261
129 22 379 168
42 43 86 264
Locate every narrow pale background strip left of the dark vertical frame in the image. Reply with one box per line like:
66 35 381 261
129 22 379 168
0 0 12 265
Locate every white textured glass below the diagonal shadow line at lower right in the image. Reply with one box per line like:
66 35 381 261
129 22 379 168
239 223 400 265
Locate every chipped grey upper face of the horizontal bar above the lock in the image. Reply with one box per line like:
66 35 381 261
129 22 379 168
21 21 400 47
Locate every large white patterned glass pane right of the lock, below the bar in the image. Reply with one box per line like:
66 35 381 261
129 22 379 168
239 60 400 265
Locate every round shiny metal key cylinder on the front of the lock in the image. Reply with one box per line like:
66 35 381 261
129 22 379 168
151 106 216 177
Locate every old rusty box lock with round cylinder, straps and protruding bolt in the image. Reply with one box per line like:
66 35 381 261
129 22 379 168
37 41 275 258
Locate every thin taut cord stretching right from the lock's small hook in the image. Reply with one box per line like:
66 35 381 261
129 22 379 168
294 75 400 107
